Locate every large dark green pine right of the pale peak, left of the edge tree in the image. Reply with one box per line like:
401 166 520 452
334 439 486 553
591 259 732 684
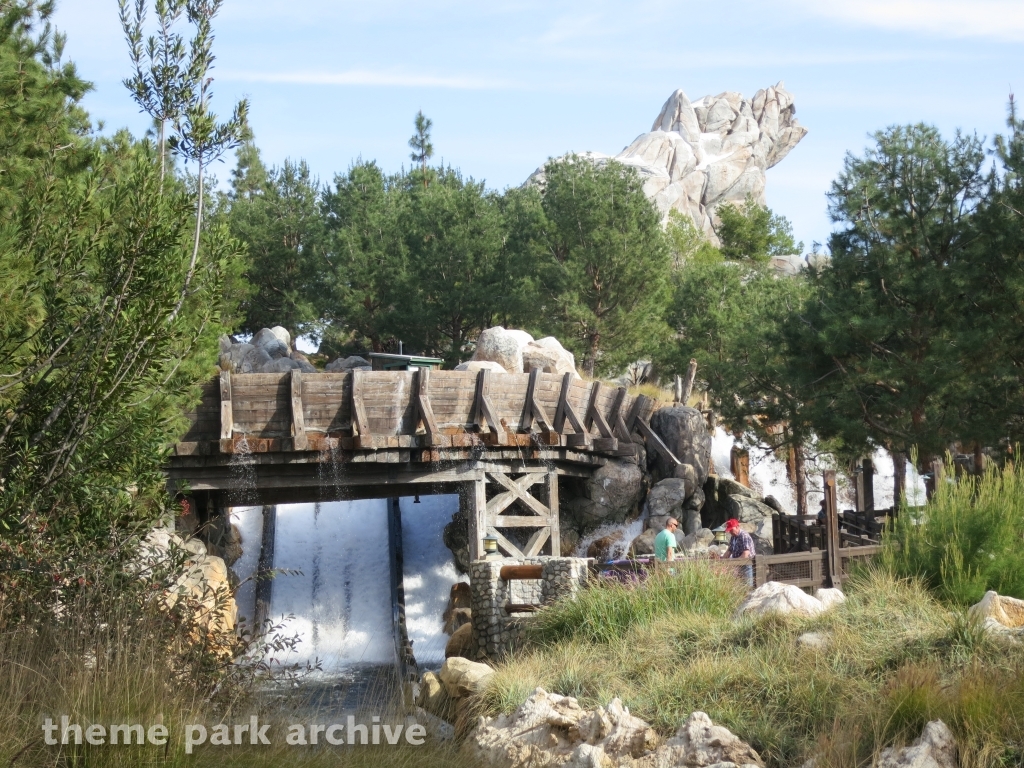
796 125 1002 457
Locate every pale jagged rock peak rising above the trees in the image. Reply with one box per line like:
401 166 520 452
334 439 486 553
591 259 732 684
528 81 807 244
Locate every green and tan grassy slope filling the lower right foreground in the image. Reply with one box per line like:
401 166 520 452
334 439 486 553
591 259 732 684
485 567 1024 768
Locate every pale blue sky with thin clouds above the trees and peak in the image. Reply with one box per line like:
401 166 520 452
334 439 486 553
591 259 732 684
54 0 1024 250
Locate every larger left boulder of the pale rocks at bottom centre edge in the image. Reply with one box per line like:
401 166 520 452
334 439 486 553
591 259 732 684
463 688 657 768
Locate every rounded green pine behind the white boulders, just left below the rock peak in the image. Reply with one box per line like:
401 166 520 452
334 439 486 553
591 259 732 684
540 156 672 376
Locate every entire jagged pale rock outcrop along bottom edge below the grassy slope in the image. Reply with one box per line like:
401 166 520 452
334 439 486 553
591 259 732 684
463 688 763 768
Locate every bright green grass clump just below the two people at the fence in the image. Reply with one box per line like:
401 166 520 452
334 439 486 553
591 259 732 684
528 563 743 645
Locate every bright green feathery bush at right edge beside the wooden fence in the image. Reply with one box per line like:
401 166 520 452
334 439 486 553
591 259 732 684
887 456 1024 606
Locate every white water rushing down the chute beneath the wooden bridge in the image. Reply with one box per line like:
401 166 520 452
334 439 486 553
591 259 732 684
231 496 465 674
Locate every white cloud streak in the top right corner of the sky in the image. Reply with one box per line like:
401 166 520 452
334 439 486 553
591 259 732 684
790 0 1024 41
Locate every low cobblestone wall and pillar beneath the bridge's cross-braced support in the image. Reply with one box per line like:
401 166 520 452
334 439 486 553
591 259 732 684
469 557 589 658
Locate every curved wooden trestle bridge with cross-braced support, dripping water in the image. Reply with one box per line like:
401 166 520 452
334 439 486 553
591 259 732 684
167 369 678 559
